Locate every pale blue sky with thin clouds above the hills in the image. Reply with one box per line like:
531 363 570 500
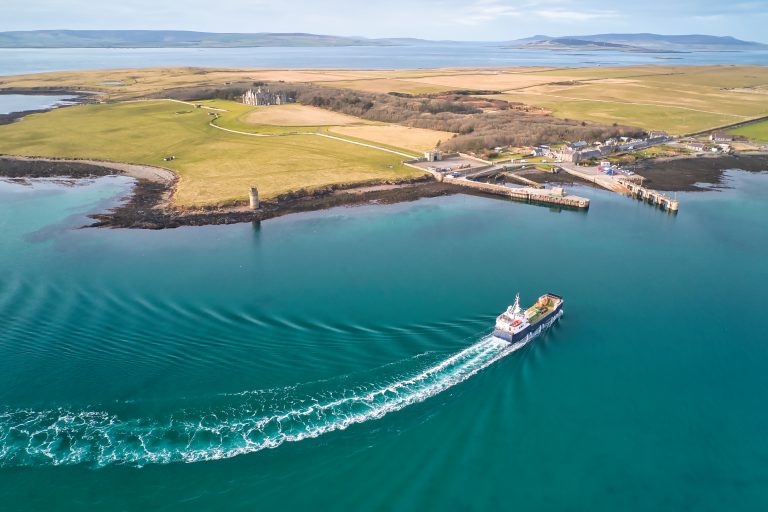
0 0 768 43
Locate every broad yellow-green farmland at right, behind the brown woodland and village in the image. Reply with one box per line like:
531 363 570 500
486 66 768 135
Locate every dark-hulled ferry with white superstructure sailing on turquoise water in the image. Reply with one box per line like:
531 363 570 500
493 293 563 343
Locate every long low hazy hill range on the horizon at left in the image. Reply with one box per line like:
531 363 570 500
0 30 410 48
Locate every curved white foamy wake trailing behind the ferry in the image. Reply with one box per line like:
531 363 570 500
0 335 536 467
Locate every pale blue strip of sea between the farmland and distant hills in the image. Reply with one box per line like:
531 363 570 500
0 44 768 76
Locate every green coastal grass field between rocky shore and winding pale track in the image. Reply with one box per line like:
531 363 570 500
0 101 421 207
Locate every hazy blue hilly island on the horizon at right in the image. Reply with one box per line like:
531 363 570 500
508 34 768 51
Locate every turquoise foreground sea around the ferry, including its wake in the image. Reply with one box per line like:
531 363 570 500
0 173 768 511
